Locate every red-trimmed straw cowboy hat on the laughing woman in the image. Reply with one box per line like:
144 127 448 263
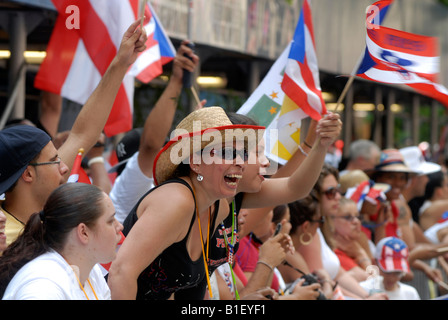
153 107 265 185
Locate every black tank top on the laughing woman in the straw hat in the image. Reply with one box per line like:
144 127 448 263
123 179 219 300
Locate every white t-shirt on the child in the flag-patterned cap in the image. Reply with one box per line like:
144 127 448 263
359 276 420 300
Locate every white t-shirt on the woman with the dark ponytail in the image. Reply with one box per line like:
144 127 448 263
2 250 111 300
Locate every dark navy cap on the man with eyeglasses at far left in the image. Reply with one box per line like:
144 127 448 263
0 125 51 194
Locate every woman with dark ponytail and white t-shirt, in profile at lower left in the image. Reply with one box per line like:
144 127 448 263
0 183 123 300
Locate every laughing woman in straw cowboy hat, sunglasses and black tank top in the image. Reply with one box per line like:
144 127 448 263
109 107 282 299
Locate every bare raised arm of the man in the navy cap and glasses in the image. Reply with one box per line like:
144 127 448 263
59 20 146 177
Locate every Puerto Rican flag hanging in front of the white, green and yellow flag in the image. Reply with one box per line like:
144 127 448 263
281 0 327 120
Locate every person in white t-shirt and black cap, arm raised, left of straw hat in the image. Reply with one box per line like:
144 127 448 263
110 40 200 222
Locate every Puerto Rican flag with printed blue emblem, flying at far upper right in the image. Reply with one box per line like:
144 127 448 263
356 0 448 107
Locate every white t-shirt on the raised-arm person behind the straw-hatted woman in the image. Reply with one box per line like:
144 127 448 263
109 152 154 223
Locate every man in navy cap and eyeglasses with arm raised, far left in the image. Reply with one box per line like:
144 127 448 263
0 21 147 245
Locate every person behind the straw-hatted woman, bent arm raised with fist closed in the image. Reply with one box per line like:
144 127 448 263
186 112 342 294
